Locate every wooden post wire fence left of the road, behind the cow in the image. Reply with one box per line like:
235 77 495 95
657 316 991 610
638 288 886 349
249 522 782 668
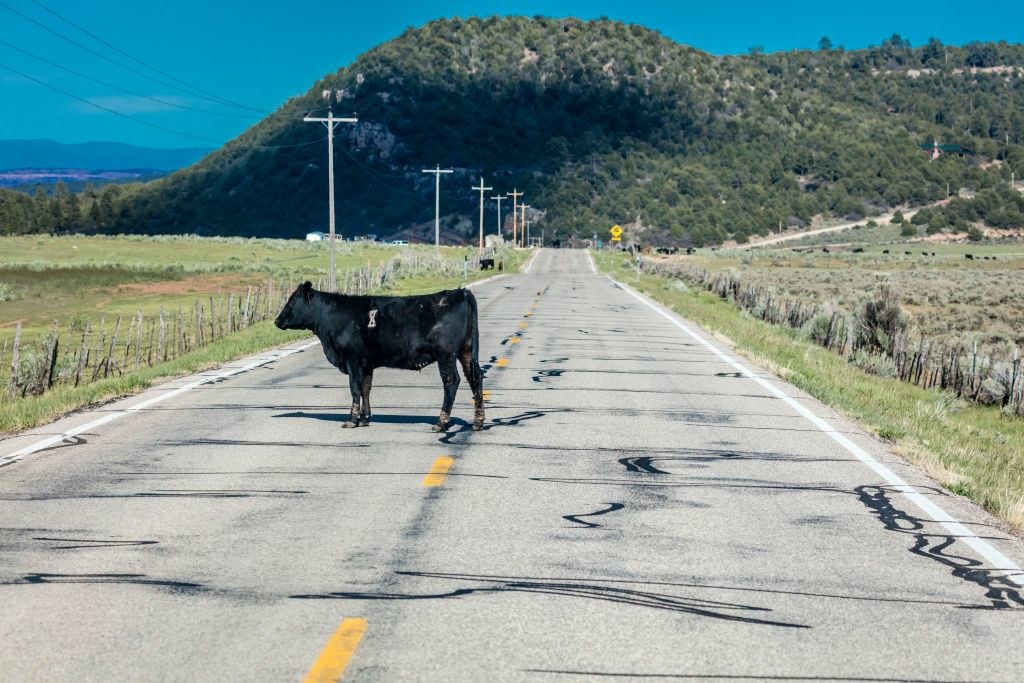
0 250 479 403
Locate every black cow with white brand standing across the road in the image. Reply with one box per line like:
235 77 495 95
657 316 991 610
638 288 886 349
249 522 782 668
273 283 483 431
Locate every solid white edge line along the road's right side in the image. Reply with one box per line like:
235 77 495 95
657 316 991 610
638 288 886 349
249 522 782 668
607 275 1024 586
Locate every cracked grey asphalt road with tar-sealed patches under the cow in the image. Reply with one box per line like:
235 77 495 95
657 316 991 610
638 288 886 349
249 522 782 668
0 250 1024 681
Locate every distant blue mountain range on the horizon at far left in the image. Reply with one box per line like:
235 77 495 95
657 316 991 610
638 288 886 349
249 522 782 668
0 139 210 171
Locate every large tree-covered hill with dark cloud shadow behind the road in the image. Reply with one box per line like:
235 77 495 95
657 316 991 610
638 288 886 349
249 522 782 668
0 17 1024 245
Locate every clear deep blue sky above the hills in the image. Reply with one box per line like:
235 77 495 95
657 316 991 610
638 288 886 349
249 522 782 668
0 0 1024 147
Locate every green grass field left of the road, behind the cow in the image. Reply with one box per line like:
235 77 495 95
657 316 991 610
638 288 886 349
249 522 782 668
0 236 531 433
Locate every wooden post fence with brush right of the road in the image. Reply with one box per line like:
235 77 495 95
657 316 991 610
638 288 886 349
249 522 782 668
640 257 1024 416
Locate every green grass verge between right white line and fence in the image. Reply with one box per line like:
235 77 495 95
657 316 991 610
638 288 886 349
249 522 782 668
598 257 1024 530
